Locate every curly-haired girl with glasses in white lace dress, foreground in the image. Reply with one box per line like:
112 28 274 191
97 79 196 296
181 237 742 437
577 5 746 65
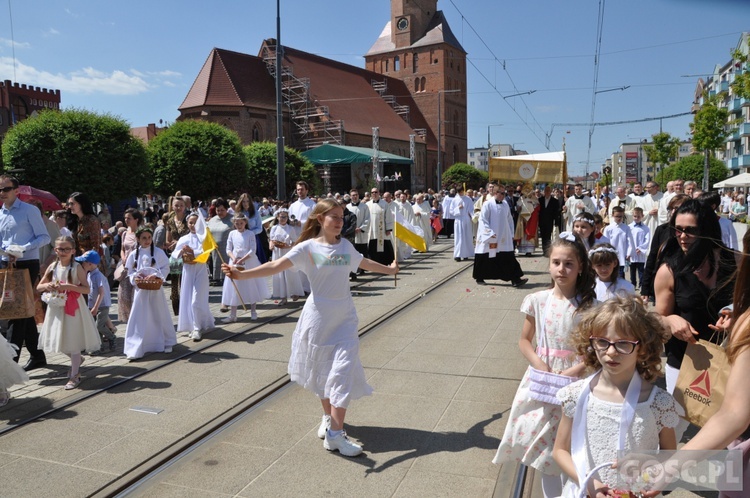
554 296 679 497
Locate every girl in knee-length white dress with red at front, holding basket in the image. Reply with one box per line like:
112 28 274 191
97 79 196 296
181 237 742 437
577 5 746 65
36 236 101 390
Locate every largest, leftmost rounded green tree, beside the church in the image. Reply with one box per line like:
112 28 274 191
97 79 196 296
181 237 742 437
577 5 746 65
2 109 151 203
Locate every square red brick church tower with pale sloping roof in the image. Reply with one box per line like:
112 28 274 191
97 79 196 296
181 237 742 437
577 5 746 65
365 0 467 186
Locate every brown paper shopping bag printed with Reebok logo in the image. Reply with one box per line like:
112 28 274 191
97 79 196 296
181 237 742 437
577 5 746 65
673 340 729 427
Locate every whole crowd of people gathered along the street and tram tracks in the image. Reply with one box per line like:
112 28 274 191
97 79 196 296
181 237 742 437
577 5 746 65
0 175 750 497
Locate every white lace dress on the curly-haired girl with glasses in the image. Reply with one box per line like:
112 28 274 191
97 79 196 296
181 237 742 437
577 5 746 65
557 379 680 497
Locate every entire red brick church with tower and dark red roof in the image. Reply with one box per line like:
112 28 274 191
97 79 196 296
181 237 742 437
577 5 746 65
178 0 467 190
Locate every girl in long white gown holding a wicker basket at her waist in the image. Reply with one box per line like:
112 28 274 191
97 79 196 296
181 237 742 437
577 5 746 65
124 226 177 361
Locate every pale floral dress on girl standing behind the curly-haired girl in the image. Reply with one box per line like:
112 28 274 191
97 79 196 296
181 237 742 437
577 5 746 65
492 289 592 475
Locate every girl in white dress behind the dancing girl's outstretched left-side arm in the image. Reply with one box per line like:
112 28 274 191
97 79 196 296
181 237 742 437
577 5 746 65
221 213 269 323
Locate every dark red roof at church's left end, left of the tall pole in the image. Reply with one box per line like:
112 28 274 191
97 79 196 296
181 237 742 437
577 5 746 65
178 48 276 110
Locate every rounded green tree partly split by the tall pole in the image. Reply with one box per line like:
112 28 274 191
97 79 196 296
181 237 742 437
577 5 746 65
242 142 320 199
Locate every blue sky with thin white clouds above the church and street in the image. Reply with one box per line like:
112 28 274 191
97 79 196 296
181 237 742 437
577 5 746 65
0 0 750 174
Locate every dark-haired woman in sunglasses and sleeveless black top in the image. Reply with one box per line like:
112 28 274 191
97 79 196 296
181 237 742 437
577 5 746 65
654 199 736 393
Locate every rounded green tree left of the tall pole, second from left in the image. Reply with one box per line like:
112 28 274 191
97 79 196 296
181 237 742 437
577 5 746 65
148 120 247 199
